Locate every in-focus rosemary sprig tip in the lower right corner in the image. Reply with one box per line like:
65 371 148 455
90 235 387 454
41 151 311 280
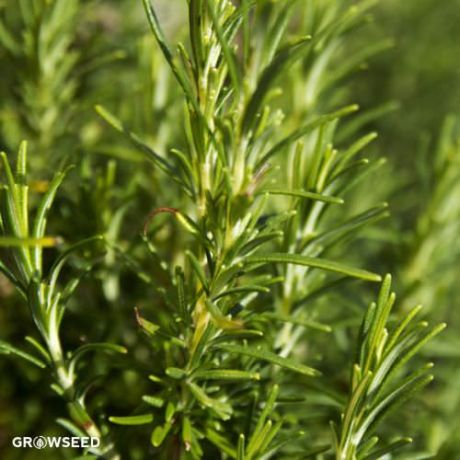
336 275 445 459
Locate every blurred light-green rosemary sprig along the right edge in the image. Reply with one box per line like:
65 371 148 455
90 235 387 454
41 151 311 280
380 116 459 458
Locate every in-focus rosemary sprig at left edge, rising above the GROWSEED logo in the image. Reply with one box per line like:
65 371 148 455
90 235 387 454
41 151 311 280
0 143 122 458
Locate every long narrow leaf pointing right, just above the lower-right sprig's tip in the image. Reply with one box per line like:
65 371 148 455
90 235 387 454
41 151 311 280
244 253 381 282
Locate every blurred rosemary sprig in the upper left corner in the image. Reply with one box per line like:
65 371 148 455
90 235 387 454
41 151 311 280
0 0 124 169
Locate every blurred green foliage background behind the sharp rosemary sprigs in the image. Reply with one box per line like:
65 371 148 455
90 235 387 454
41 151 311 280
0 0 460 460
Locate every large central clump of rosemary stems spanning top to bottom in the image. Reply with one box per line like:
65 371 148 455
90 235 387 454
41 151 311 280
97 1 442 459
